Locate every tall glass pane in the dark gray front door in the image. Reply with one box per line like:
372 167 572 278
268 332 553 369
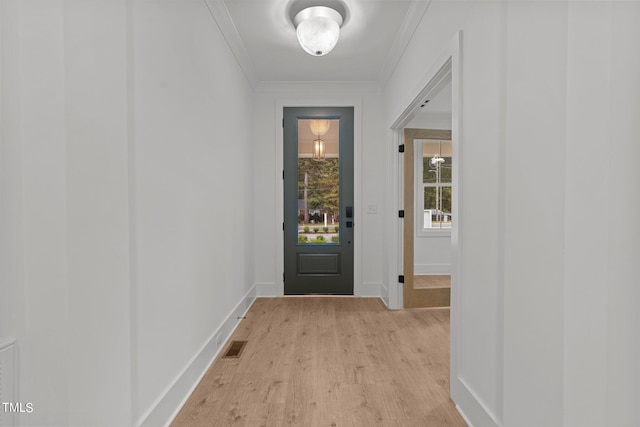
298 119 340 245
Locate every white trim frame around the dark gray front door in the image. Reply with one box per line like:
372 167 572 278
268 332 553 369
274 95 362 297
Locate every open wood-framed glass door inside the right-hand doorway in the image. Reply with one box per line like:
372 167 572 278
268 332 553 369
402 127 455 308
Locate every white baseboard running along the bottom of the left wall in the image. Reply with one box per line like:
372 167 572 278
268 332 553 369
137 285 256 427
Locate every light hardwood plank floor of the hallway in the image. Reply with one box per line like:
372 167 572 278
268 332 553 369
172 297 466 427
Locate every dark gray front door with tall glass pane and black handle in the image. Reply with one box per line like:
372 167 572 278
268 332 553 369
284 107 354 295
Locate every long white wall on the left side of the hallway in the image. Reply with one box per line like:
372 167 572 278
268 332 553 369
0 0 254 426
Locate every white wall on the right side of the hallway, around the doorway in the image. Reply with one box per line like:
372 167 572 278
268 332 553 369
384 2 640 426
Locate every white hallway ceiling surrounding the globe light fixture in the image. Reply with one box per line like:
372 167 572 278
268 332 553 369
205 0 430 87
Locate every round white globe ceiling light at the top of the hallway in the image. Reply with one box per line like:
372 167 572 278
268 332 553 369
293 6 344 56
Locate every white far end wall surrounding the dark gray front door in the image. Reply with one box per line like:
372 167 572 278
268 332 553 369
253 83 388 296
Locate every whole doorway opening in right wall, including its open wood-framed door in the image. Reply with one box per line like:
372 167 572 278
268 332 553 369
392 52 461 308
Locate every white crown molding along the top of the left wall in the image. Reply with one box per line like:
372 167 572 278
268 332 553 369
203 0 257 89
